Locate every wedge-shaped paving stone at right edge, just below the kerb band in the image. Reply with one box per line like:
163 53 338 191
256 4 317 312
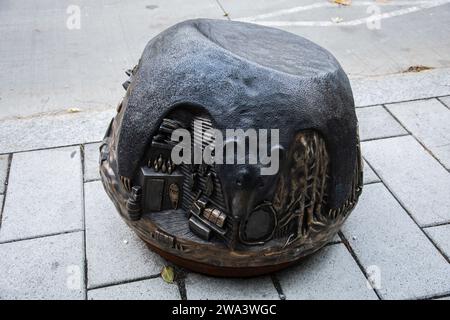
386 99 450 169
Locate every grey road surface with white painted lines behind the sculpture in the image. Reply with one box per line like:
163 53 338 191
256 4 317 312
0 0 450 118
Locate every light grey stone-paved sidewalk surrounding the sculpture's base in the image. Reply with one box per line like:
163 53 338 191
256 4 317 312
0 69 450 299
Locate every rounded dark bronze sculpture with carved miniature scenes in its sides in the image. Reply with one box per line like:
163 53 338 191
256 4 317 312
100 19 362 276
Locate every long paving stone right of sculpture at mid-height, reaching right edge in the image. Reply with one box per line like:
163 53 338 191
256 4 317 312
362 136 450 226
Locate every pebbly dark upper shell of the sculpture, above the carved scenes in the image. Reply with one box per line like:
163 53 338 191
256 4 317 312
117 19 357 207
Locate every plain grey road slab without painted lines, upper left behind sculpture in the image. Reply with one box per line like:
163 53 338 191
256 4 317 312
0 0 224 118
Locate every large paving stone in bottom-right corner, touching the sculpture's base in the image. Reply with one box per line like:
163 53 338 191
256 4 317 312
343 183 450 299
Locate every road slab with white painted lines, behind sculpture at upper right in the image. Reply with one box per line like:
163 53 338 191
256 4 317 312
219 0 450 78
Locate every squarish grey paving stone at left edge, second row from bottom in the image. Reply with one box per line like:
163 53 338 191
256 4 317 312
0 147 83 241
